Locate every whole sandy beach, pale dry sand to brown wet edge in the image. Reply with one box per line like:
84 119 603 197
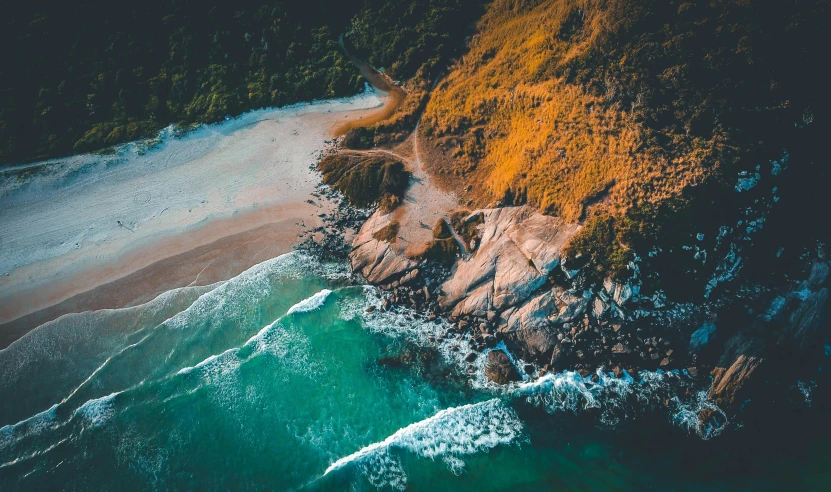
0 85 400 348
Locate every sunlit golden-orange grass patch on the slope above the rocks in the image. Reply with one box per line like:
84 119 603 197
422 0 706 221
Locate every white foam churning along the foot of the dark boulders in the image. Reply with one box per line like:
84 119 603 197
342 287 729 439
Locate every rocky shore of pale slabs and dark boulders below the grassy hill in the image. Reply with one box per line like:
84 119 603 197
326 172 831 424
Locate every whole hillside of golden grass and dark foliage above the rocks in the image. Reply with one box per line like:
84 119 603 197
421 0 831 294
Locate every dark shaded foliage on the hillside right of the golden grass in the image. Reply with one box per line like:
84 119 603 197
552 0 831 290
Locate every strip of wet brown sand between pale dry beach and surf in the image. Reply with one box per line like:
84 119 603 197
0 203 322 350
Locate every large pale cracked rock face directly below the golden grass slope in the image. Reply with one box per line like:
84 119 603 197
440 207 580 316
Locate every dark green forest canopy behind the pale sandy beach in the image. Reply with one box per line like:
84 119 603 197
0 0 474 165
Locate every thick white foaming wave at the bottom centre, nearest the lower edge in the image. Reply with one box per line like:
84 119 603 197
324 398 524 487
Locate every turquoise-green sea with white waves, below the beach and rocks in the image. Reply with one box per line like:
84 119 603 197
0 253 829 490
